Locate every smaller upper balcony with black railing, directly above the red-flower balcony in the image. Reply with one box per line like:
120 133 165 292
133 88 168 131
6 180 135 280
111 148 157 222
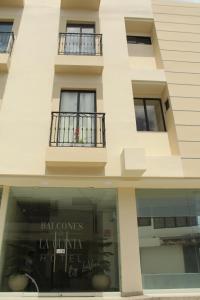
55 33 103 75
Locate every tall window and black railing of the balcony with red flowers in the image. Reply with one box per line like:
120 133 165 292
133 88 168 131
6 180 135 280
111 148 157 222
50 90 105 148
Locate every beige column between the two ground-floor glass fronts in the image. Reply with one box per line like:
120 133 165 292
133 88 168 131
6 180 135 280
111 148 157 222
118 188 143 296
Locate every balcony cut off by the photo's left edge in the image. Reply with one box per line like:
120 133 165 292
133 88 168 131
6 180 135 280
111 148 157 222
0 32 14 72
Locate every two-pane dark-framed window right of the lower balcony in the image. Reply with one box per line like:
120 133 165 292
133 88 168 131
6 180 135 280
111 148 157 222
134 98 166 131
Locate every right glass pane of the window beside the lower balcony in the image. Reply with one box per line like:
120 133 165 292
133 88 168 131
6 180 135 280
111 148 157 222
146 100 164 131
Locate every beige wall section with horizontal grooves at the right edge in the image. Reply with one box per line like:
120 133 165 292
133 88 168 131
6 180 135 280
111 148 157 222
152 0 200 177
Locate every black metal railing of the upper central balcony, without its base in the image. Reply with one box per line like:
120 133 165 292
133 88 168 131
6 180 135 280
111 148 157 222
58 33 102 56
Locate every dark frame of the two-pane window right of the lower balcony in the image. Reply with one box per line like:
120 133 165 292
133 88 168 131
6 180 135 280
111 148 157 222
134 97 167 132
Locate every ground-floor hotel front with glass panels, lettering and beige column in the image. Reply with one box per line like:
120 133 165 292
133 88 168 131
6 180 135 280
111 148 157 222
0 179 200 299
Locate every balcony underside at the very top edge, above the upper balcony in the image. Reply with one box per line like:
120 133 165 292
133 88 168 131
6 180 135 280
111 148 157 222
61 0 101 10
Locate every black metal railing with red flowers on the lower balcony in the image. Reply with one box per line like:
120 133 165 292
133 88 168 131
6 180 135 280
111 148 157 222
49 112 106 148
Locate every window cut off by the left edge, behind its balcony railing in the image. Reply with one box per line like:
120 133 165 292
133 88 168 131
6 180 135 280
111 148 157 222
0 22 13 53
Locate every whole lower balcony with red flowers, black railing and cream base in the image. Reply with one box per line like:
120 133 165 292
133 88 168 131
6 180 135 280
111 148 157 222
46 112 107 168
